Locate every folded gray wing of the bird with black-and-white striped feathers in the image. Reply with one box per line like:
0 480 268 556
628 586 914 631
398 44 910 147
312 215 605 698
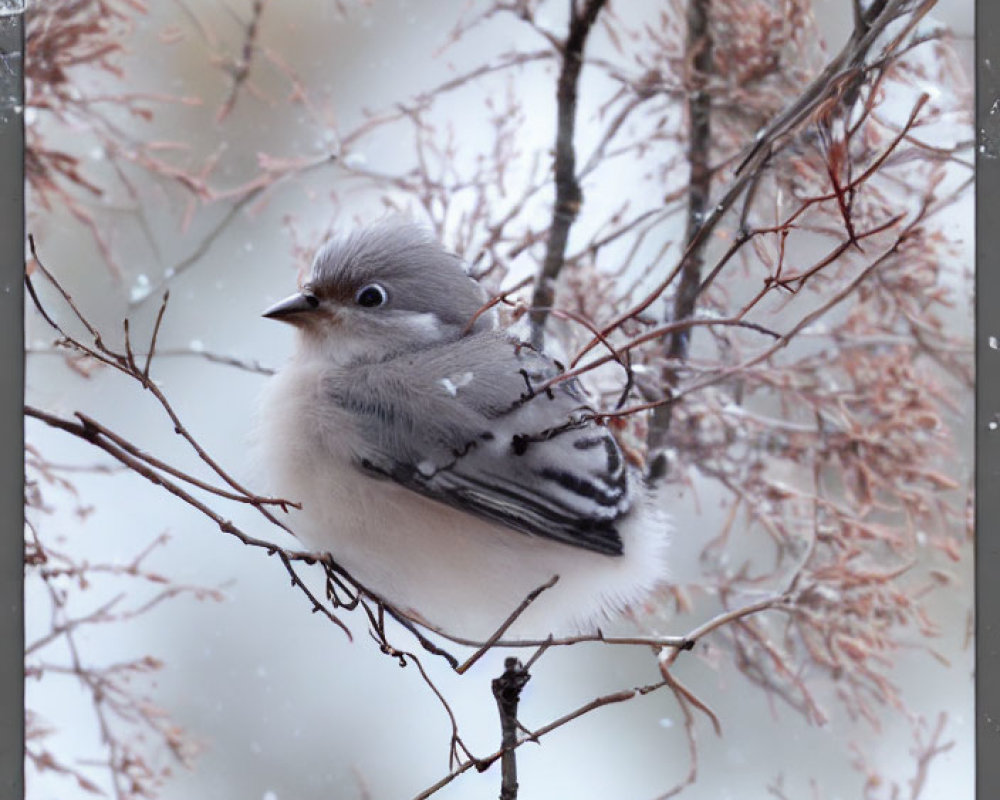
325 333 632 555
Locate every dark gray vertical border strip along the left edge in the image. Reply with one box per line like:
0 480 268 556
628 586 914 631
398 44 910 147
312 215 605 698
0 0 24 800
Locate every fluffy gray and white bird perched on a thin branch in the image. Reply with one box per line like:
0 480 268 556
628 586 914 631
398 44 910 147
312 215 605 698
256 220 669 642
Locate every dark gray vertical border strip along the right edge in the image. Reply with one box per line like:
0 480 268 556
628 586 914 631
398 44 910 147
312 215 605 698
976 0 1000 800
